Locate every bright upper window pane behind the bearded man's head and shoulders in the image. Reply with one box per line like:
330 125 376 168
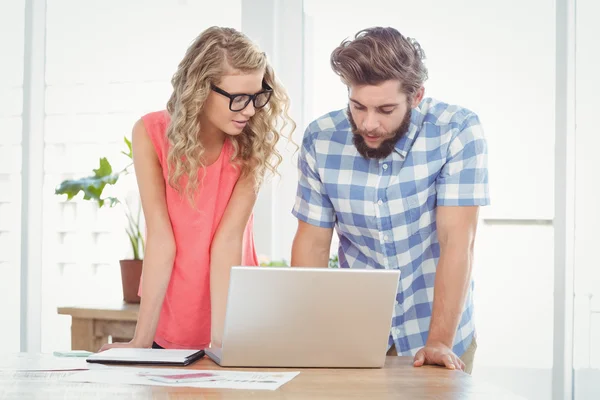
304 0 555 219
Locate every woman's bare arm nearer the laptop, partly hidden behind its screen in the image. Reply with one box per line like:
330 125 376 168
210 176 257 347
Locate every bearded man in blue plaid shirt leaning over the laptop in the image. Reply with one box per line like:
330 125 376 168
292 28 489 373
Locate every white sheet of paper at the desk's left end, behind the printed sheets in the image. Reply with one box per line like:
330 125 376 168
0 353 106 371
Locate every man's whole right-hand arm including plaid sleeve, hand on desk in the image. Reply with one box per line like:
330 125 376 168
414 113 490 369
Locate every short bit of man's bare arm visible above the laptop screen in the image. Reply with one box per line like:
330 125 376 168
291 220 333 268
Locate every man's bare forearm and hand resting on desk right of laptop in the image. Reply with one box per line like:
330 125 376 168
415 206 479 369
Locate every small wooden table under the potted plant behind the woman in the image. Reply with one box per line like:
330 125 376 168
58 303 140 351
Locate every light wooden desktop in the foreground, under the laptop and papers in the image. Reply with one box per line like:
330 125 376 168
0 357 521 400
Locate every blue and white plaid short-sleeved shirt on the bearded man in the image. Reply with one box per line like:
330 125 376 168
292 99 489 356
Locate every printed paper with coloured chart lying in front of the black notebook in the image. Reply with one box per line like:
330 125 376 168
65 367 300 390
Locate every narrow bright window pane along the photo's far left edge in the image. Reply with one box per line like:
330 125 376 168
0 0 25 352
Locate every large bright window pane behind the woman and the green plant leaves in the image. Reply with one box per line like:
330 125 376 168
42 0 241 351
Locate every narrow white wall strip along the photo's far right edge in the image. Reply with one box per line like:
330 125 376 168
573 0 600 400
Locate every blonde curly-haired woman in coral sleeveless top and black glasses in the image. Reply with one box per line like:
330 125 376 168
102 27 295 350
